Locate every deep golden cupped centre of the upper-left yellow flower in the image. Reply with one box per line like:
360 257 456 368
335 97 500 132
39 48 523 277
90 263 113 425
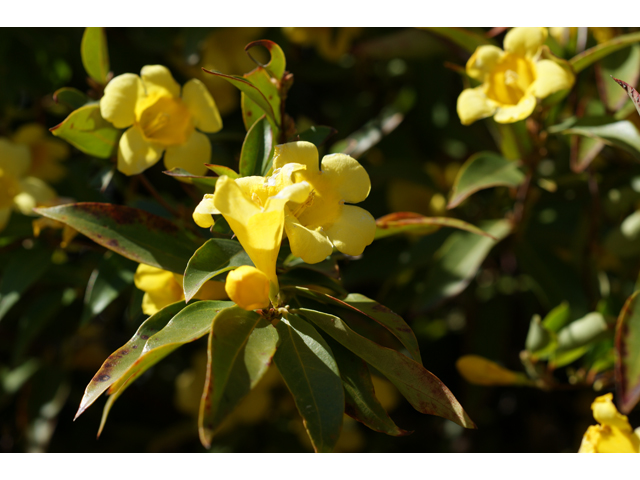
136 95 194 146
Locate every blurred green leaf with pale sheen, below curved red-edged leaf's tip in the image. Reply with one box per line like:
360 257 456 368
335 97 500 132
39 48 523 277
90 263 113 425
418 220 511 309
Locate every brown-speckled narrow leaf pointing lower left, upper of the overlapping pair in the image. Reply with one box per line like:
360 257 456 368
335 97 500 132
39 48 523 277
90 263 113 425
74 302 185 420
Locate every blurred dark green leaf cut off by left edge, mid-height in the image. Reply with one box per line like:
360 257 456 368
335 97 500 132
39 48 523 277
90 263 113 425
0 246 51 320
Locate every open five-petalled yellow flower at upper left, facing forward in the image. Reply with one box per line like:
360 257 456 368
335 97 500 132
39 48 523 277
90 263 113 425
100 65 222 175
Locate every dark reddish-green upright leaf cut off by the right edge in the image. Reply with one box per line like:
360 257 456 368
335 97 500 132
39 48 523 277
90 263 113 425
615 292 640 414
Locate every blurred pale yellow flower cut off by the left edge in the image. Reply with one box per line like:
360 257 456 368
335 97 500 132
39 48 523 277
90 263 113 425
0 138 56 230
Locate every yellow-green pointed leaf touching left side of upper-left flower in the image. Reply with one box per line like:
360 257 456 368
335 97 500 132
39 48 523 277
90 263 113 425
49 103 122 158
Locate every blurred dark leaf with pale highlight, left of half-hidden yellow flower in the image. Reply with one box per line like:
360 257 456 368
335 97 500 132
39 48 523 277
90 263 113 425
80 252 138 325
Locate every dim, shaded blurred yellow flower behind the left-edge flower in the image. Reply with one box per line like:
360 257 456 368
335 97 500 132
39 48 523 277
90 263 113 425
13 123 69 182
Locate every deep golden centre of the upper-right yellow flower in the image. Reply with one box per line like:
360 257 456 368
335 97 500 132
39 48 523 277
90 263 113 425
486 53 536 105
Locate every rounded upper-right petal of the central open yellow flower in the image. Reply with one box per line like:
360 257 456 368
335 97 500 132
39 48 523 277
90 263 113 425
314 153 371 203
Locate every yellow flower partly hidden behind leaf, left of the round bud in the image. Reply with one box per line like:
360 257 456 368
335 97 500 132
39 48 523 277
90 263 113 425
133 263 227 315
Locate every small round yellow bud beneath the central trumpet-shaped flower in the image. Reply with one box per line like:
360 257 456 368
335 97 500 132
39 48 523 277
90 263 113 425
225 265 269 310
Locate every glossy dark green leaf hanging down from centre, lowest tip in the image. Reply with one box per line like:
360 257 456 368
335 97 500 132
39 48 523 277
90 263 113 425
274 315 344 452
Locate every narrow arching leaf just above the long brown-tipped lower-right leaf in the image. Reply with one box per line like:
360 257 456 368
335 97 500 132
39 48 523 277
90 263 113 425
296 287 422 364
